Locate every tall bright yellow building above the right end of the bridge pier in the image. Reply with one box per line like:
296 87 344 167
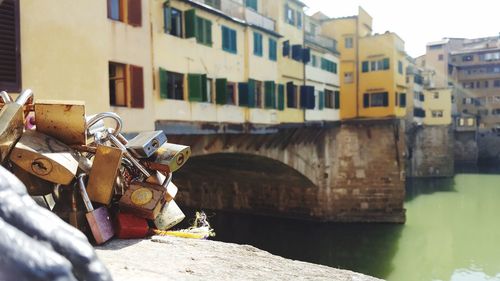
322 7 406 119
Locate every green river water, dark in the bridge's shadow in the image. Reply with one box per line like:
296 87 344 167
202 167 500 281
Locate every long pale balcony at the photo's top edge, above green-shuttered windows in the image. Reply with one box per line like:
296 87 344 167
192 0 276 31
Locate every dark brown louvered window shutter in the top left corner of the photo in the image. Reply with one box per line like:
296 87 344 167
0 0 21 92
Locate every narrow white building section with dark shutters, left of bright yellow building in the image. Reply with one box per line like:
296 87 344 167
305 12 340 121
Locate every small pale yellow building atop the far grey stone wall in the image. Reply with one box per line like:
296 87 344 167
424 88 453 125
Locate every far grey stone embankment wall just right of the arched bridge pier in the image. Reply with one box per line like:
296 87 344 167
407 125 454 178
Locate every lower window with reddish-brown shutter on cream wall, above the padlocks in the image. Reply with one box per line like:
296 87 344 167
108 62 144 108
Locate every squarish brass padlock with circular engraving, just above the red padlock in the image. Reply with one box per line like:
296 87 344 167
119 179 166 220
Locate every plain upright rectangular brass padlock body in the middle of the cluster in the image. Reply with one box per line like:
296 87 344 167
87 145 123 205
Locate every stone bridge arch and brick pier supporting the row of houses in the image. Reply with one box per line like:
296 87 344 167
160 119 405 223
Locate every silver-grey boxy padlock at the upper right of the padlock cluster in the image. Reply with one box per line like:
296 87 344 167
126 131 167 158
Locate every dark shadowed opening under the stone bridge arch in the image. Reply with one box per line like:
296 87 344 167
174 153 319 219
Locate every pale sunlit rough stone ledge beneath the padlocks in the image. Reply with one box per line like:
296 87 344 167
97 237 380 281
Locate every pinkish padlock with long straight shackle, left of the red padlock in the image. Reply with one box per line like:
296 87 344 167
78 174 115 245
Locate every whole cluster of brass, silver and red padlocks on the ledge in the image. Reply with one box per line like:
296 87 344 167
0 90 191 244
